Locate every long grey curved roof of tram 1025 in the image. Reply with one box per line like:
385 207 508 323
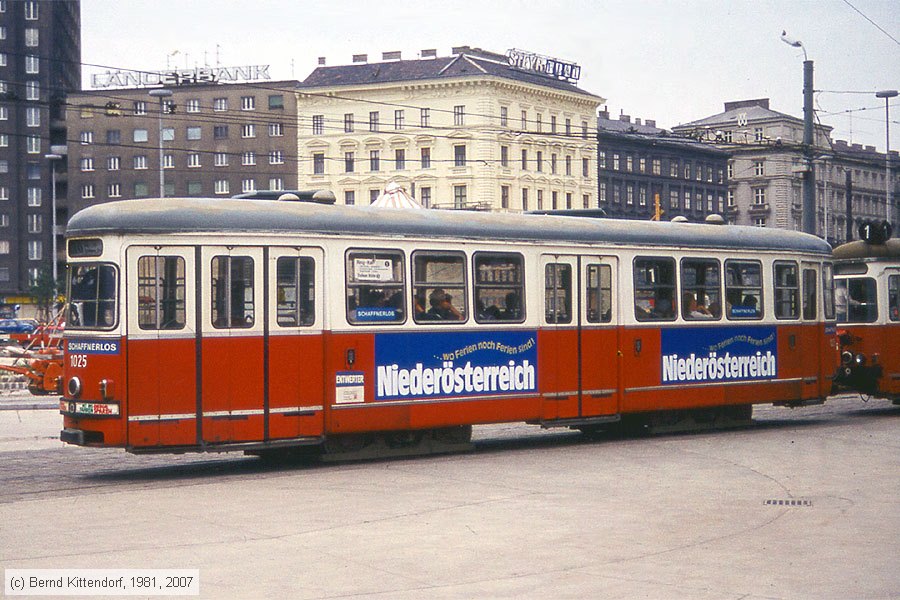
66 198 831 255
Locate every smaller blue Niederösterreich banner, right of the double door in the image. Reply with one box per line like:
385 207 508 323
661 326 778 385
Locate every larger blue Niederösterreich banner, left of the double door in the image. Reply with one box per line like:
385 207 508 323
375 331 538 400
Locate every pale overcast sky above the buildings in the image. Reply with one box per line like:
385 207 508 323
81 0 900 152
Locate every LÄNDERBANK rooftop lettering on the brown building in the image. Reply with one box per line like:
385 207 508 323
91 65 271 88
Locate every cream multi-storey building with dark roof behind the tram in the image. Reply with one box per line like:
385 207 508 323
297 46 605 211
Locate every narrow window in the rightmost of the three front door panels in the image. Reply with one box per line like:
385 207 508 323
275 256 316 327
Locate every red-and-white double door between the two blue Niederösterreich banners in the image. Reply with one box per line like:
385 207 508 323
540 255 618 419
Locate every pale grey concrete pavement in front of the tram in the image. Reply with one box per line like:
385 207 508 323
0 398 900 600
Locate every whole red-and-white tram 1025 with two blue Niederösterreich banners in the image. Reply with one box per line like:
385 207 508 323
61 198 838 452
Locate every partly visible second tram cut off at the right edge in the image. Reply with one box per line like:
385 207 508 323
834 229 900 403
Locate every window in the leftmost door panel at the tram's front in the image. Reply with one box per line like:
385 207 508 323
137 256 185 330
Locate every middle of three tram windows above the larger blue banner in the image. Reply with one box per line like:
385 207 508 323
412 252 467 323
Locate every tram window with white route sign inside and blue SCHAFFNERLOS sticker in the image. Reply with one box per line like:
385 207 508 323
344 248 407 325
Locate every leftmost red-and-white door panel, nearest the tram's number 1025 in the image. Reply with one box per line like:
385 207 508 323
125 246 197 447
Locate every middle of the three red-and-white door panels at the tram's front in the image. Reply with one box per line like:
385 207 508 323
199 246 266 443
